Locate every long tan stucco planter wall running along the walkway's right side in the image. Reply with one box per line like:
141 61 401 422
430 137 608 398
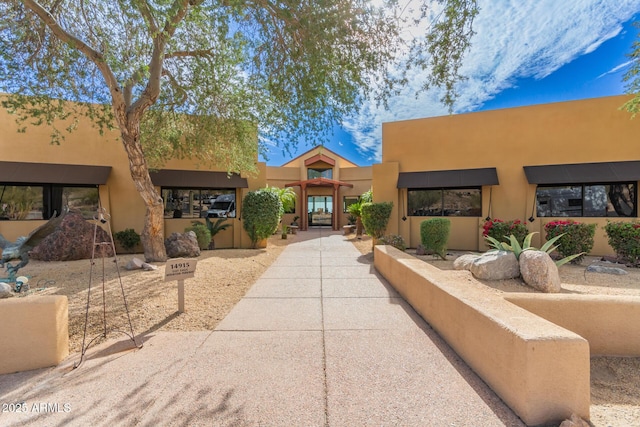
374 246 590 426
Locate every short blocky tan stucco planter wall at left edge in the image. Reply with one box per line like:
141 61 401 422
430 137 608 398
0 295 69 374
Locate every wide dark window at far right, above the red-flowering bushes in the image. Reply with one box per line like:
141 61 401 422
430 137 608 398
536 182 637 217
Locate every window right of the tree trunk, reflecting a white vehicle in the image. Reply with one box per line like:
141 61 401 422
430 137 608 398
162 187 236 218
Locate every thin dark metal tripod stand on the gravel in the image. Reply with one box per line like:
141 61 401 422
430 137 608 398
73 207 142 369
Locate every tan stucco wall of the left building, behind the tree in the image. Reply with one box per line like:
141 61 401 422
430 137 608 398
0 105 266 248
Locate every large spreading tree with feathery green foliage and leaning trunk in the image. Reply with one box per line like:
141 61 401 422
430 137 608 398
0 0 477 262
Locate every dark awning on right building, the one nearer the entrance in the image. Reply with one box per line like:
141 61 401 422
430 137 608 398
398 168 498 188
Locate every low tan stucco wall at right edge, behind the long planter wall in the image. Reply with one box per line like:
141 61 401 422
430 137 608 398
505 294 640 356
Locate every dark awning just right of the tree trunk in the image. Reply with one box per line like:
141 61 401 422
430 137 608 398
150 169 249 188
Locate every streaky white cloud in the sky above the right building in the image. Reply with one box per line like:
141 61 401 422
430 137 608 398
343 0 640 161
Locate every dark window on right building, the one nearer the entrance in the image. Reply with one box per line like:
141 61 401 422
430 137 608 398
408 187 482 216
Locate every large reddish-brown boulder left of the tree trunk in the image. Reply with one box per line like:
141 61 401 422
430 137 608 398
29 212 113 261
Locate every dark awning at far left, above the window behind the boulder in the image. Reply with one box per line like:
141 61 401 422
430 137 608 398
0 162 111 185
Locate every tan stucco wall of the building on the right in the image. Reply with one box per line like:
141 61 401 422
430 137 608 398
380 96 640 255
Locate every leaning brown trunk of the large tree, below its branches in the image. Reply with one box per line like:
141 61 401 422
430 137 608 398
122 127 167 262
